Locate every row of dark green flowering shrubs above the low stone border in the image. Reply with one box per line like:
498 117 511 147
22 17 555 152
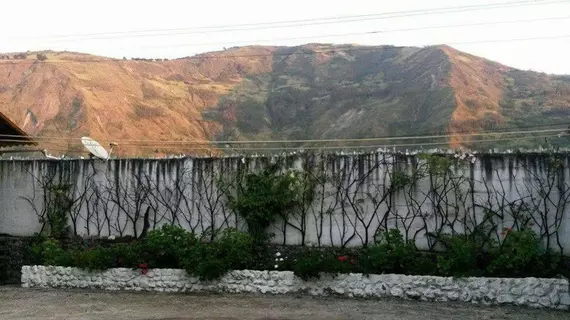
27 226 569 280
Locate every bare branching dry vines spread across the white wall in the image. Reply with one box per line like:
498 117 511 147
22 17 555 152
24 154 570 251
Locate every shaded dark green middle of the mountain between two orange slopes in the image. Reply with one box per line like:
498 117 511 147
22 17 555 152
202 45 456 143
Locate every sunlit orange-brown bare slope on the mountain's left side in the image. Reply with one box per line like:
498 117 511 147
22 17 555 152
0 47 272 155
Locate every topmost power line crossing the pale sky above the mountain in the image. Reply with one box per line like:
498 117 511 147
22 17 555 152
13 0 568 40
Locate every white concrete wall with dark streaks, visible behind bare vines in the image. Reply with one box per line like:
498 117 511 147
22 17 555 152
0 154 570 252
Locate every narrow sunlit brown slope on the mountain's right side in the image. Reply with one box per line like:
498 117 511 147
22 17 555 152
441 46 511 147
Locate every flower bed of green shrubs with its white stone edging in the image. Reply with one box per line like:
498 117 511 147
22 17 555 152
21 226 570 309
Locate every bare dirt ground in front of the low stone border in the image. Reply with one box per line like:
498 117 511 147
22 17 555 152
0 287 570 320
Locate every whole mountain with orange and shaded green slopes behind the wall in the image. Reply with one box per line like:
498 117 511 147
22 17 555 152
0 44 570 155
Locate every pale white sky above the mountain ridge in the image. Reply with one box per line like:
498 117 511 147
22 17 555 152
0 0 570 74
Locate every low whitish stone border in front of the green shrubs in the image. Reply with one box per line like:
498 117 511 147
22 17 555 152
22 266 570 310
